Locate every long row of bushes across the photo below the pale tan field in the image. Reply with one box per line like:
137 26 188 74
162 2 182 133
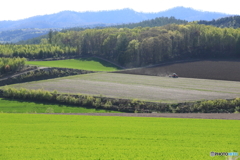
0 88 240 113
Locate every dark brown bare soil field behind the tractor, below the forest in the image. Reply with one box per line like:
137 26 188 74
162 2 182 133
118 60 240 81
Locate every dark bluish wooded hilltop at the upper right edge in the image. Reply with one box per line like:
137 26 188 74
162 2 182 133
198 16 240 28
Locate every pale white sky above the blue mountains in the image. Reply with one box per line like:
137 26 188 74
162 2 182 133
0 0 240 21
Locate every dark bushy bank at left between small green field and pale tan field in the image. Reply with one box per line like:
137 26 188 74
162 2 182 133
0 68 93 86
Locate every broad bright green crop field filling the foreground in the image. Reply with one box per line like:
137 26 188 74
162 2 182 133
0 113 240 160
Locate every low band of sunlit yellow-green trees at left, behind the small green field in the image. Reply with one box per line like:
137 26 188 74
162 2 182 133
0 43 77 59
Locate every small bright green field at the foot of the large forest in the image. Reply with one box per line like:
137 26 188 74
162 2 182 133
26 58 118 71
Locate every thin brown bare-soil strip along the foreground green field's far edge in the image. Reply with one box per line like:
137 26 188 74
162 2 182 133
44 113 240 120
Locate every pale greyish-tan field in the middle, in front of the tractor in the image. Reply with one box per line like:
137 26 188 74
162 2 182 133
5 73 240 103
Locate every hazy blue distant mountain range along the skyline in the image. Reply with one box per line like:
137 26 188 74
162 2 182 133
0 7 229 31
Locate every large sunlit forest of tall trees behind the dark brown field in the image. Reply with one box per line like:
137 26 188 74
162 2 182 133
48 22 240 67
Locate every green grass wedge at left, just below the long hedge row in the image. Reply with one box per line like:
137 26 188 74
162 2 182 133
0 98 119 113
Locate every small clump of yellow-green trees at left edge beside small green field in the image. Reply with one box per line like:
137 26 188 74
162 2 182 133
0 57 26 75
